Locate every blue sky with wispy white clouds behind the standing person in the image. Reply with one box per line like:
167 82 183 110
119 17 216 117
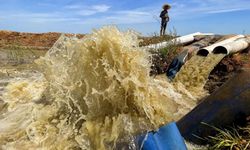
0 0 250 35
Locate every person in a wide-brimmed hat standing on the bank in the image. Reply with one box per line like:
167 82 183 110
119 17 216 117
160 4 171 36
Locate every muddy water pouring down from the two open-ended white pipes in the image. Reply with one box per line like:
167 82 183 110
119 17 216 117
174 54 226 98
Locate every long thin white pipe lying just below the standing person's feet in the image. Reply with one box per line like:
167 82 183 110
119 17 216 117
144 32 214 49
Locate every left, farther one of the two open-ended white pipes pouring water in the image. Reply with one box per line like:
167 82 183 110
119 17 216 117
197 35 245 56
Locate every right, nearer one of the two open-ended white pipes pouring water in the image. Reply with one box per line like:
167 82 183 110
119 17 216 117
213 38 249 55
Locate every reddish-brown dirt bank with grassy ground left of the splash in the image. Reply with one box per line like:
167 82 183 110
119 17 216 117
0 31 84 67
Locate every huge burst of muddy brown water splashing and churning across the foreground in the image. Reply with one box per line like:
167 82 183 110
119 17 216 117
0 27 226 150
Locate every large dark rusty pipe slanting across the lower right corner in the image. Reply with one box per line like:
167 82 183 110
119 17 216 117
177 69 250 144
